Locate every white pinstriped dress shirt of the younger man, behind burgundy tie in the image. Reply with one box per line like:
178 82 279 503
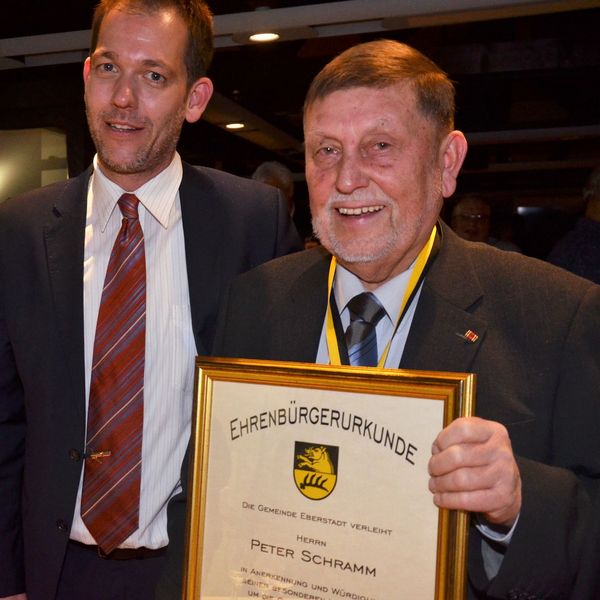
71 154 196 548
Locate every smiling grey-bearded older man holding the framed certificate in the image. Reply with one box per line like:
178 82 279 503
207 41 600 598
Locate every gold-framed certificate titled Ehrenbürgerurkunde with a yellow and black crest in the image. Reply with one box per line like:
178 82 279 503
184 359 475 600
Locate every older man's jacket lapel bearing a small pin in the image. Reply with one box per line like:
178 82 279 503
400 226 487 372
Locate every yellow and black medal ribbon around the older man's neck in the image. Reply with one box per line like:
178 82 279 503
325 227 437 369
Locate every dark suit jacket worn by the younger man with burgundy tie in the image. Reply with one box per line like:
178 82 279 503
0 164 300 600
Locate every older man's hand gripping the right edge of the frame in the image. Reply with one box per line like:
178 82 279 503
429 417 521 528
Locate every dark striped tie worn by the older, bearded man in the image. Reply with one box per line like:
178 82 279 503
346 292 385 367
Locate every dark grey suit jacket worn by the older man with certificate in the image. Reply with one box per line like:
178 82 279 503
214 227 600 600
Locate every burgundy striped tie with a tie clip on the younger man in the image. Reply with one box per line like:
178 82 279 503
81 194 146 554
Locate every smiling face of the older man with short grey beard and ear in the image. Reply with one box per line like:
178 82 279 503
304 83 466 284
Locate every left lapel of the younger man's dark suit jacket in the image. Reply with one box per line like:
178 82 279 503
43 170 91 422
